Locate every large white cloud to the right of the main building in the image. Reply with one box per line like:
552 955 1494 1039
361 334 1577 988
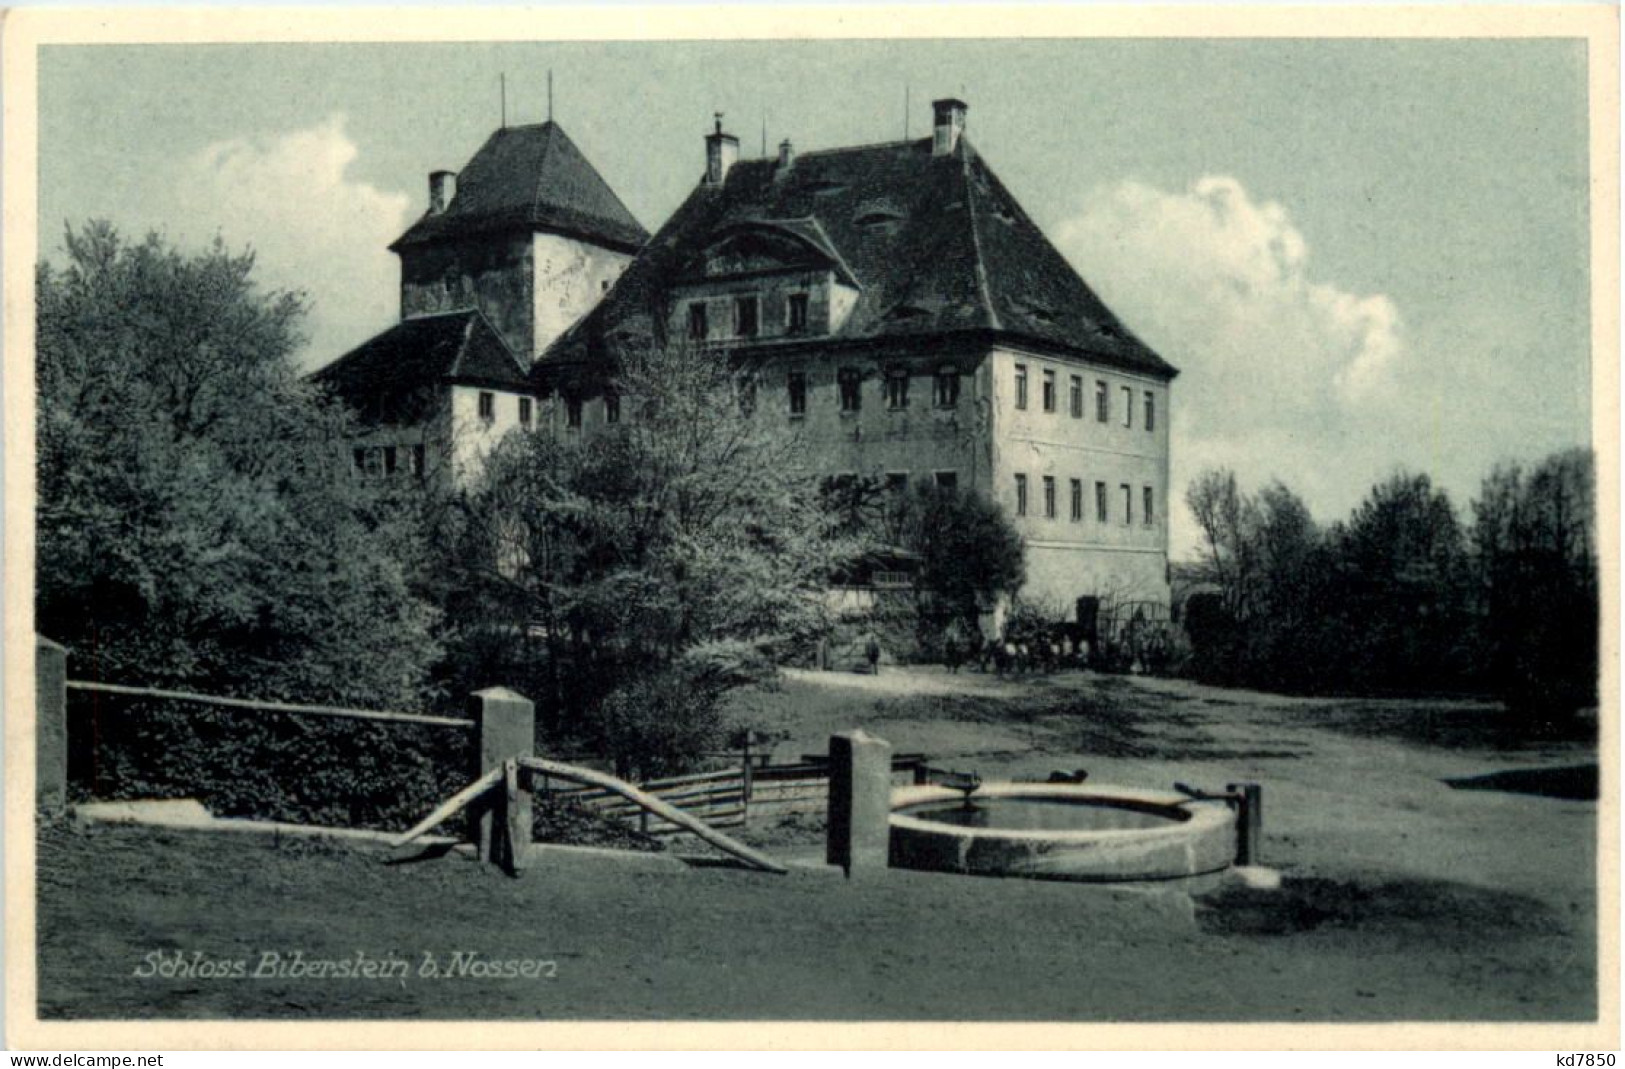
1056 175 1409 556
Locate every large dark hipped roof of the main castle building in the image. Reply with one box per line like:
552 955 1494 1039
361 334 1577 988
536 138 1178 377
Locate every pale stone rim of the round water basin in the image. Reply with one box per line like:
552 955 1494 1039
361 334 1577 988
891 780 1235 843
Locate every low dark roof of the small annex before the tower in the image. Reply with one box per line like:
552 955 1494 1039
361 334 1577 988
310 309 528 424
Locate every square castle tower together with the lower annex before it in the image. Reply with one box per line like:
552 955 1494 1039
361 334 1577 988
312 122 648 484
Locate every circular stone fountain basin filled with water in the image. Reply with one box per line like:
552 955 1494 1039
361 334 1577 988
891 783 1235 882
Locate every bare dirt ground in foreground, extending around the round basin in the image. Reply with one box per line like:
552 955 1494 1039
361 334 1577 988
39 668 1597 1022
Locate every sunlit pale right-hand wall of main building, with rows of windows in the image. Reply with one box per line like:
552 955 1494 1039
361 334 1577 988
988 348 1170 608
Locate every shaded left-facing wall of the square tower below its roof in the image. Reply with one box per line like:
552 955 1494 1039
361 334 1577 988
401 234 535 359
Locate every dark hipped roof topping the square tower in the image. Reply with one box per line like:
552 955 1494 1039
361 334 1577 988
390 122 648 252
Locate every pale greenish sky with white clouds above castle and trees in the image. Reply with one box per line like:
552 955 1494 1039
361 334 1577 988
39 39 1591 557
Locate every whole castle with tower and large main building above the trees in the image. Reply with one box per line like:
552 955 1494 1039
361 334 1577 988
319 99 1178 614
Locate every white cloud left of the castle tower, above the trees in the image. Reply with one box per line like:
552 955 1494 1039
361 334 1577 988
177 115 411 367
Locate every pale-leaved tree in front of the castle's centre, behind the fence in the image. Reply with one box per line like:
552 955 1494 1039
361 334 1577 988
453 346 843 768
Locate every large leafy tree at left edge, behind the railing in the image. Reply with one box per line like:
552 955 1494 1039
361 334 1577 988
36 223 436 825
